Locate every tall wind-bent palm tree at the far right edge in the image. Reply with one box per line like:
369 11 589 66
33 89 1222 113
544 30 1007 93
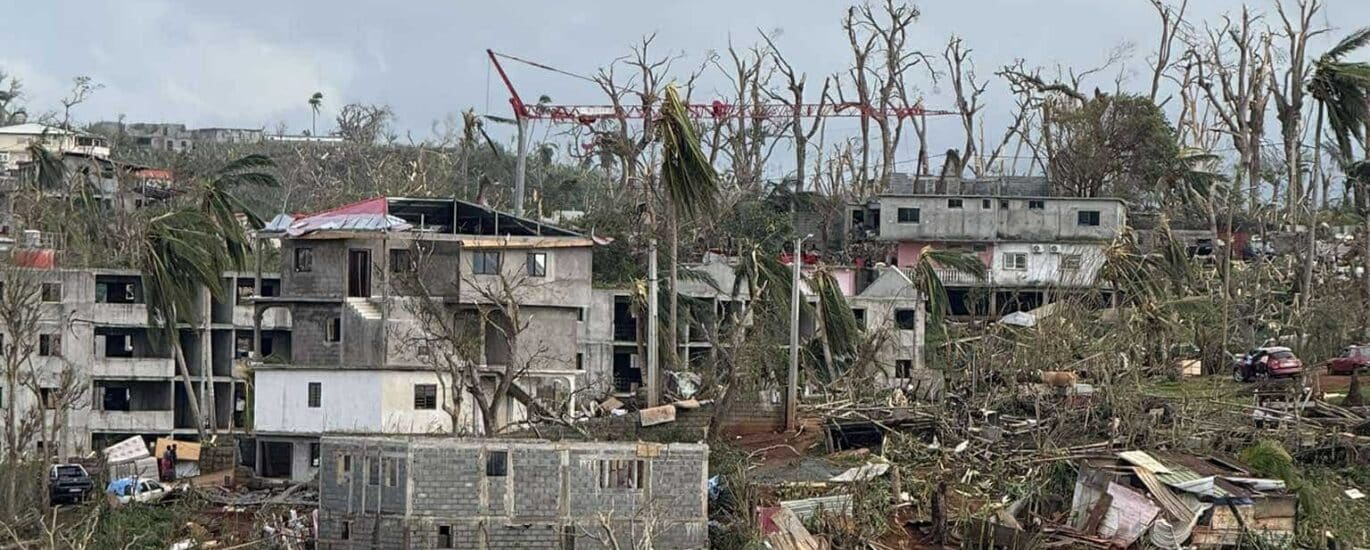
1300 27 1370 304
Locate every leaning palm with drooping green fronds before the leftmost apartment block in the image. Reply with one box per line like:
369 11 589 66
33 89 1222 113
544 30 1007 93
137 155 277 442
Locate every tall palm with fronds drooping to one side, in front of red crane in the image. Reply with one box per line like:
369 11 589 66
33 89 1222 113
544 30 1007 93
653 85 718 378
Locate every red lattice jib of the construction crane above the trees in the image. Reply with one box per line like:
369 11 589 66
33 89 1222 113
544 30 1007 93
485 49 960 125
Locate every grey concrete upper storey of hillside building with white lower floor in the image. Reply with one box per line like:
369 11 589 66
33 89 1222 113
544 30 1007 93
880 196 1126 241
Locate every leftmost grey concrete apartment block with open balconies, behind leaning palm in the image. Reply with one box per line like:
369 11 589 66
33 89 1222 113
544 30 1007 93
0 269 290 457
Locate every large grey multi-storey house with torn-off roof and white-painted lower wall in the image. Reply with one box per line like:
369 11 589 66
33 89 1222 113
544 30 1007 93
253 198 593 479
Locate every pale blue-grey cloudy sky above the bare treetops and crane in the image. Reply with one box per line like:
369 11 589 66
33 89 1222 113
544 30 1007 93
0 0 1370 174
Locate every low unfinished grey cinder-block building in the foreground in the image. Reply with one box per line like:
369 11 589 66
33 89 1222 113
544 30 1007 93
318 436 708 549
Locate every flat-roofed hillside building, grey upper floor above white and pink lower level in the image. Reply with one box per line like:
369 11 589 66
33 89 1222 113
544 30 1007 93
851 173 1128 317
